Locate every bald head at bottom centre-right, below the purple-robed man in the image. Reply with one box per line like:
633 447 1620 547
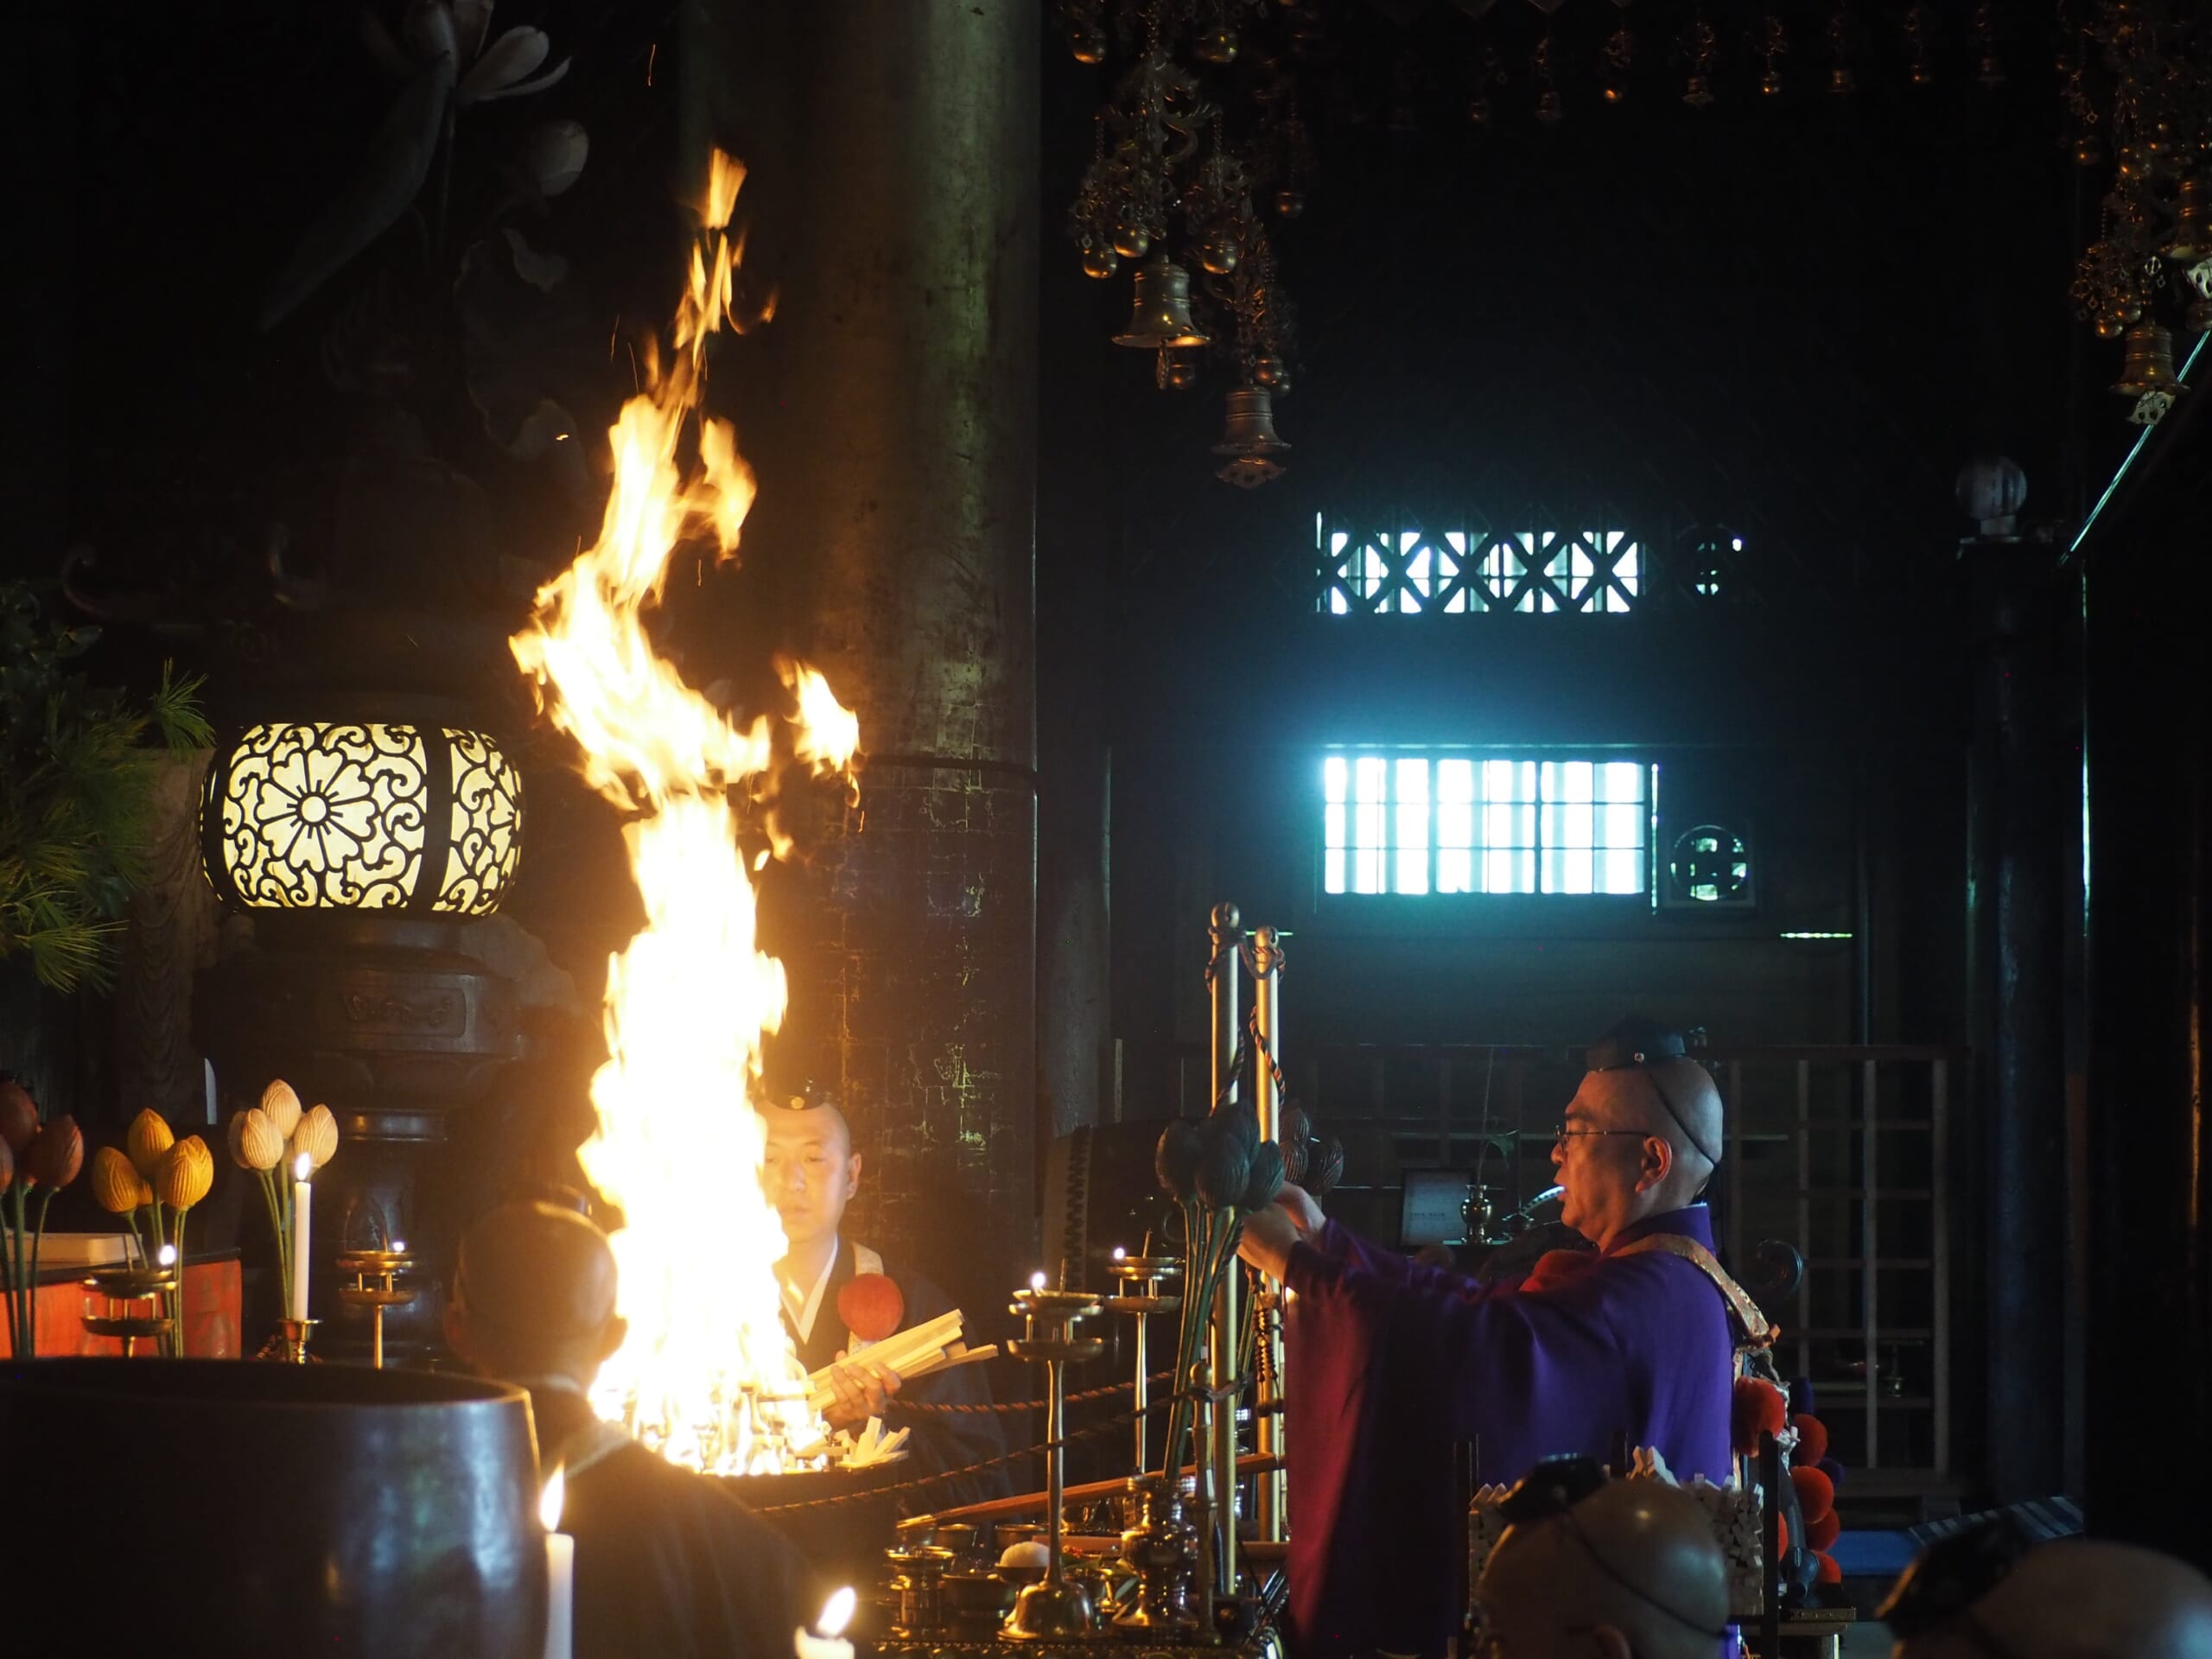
1476 1480 1727 1659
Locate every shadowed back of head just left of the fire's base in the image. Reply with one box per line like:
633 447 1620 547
447 1204 621 1382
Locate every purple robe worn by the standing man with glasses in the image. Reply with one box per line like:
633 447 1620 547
1283 1204 1738 1659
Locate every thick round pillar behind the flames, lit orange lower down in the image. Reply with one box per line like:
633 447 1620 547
686 0 1039 1312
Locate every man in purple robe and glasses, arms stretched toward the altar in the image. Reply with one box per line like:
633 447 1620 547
1241 1022 1757 1659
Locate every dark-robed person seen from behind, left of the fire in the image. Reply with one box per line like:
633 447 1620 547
445 1204 817 1659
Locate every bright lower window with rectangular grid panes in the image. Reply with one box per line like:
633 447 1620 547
1320 750 1650 896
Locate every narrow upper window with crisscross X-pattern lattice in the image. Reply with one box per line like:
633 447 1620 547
1314 515 1643 617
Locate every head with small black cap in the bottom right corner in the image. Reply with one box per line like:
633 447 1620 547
1880 1516 2212 1659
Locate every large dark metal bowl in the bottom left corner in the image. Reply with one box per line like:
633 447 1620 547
0 1360 546 1659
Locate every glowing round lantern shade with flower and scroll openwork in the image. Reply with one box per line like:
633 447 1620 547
201 721 522 916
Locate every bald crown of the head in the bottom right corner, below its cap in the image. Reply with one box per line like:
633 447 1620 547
1896 1540 2212 1659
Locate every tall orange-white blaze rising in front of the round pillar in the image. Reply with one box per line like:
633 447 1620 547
509 153 861 1473
